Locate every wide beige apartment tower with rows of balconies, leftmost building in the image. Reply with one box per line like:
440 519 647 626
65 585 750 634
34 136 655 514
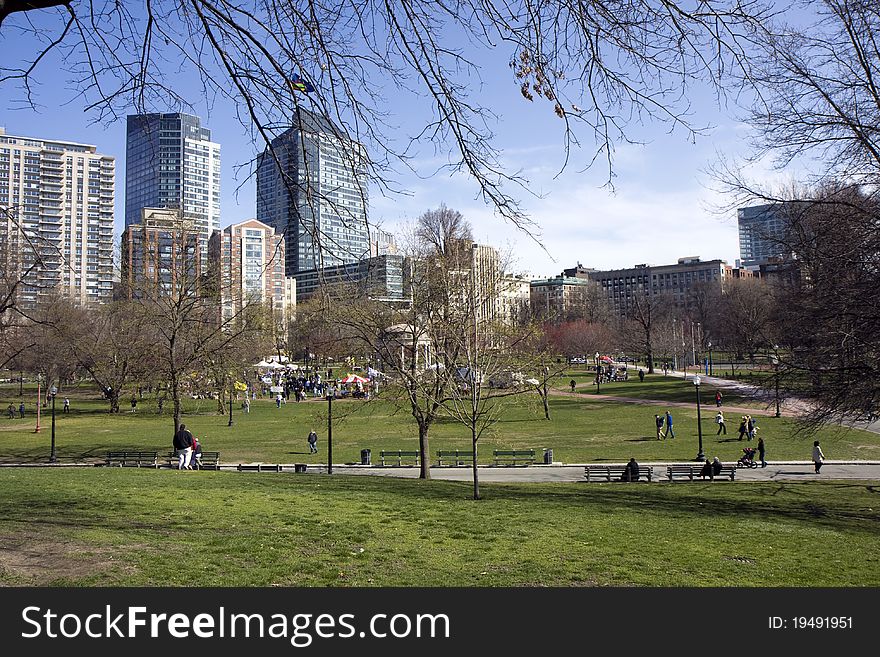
0 128 116 307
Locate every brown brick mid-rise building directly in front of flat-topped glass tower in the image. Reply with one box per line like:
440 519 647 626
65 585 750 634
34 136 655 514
122 208 203 297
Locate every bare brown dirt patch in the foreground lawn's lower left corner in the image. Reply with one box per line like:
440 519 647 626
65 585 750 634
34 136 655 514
0 530 119 586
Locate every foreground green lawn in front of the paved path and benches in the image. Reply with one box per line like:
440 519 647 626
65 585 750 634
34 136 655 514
0 468 880 587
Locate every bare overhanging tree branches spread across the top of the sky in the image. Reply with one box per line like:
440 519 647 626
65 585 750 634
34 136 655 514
0 0 769 239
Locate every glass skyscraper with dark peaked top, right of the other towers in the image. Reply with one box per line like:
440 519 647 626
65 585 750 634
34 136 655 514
257 109 371 277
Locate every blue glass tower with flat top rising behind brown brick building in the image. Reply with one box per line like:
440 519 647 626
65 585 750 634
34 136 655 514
125 112 220 266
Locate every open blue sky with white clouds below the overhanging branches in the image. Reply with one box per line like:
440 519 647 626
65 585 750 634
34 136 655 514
0 5 770 277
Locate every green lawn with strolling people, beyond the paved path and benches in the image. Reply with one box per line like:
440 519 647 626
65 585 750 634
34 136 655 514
0 376 880 463
